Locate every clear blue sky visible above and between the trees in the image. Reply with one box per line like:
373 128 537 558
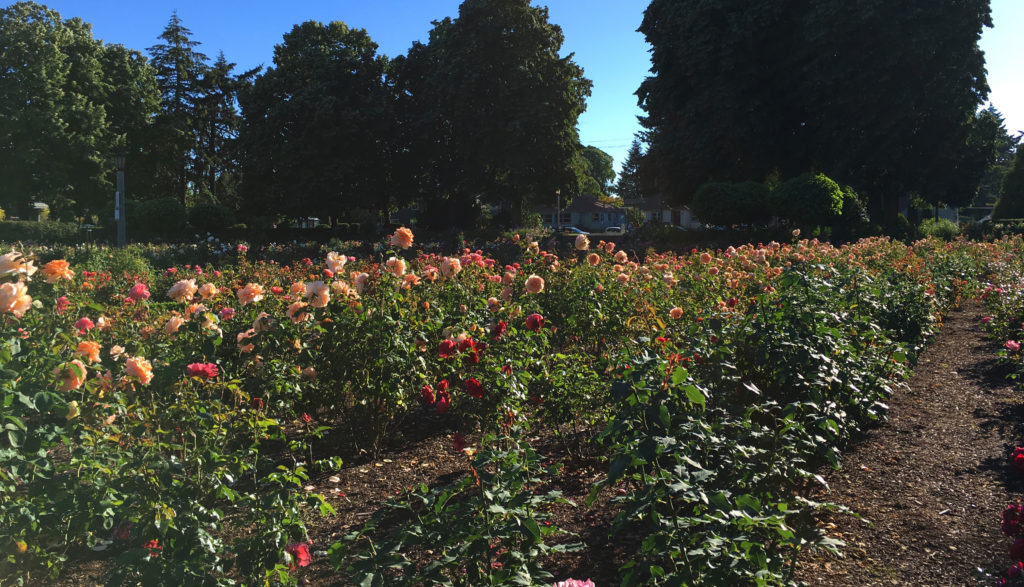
18 0 1024 168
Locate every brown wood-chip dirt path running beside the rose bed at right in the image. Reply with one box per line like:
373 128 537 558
798 303 1024 586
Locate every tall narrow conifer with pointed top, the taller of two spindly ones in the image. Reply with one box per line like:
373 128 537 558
146 11 207 205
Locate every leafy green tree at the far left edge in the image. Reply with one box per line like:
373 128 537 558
0 2 155 218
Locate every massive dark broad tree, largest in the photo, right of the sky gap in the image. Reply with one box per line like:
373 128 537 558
637 0 991 220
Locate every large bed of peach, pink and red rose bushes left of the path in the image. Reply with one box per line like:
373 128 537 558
0 229 1000 584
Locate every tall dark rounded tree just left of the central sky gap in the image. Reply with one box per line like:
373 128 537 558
397 0 591 225
